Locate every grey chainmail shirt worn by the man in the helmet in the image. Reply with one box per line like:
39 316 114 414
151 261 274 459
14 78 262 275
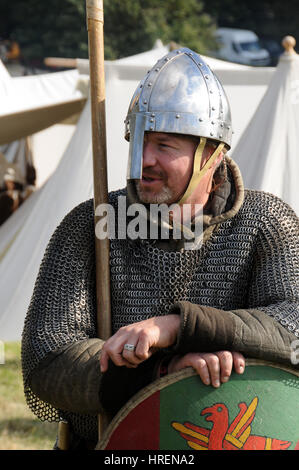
22 162 299 439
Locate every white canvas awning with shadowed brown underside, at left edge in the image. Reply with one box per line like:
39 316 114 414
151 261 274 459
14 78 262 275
0 65 86 145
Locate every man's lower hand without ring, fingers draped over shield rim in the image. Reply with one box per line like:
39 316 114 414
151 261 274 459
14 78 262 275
168 351 245 387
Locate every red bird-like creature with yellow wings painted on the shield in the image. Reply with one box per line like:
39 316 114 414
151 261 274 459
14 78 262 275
172 397 292 450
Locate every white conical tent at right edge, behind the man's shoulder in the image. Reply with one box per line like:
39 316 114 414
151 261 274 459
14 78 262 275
233 53 299 215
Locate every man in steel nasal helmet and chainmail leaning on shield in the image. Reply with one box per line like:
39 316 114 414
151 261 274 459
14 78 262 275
22 49 299 448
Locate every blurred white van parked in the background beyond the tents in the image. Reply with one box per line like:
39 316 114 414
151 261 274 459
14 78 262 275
213 28 271 66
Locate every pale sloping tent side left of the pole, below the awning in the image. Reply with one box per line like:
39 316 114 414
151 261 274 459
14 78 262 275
0 103 93 341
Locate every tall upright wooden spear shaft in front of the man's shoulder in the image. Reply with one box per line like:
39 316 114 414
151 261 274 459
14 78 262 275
86 0 111 436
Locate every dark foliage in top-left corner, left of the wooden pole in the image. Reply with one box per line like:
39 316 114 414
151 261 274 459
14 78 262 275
0 0 88 60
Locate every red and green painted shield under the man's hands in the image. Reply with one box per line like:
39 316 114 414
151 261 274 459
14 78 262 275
97 360 299 450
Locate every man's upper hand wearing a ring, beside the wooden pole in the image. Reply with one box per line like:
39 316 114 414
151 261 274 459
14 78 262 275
100 315 180 372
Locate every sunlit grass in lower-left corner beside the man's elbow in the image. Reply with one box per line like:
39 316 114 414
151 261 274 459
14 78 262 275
0 342 57 450
